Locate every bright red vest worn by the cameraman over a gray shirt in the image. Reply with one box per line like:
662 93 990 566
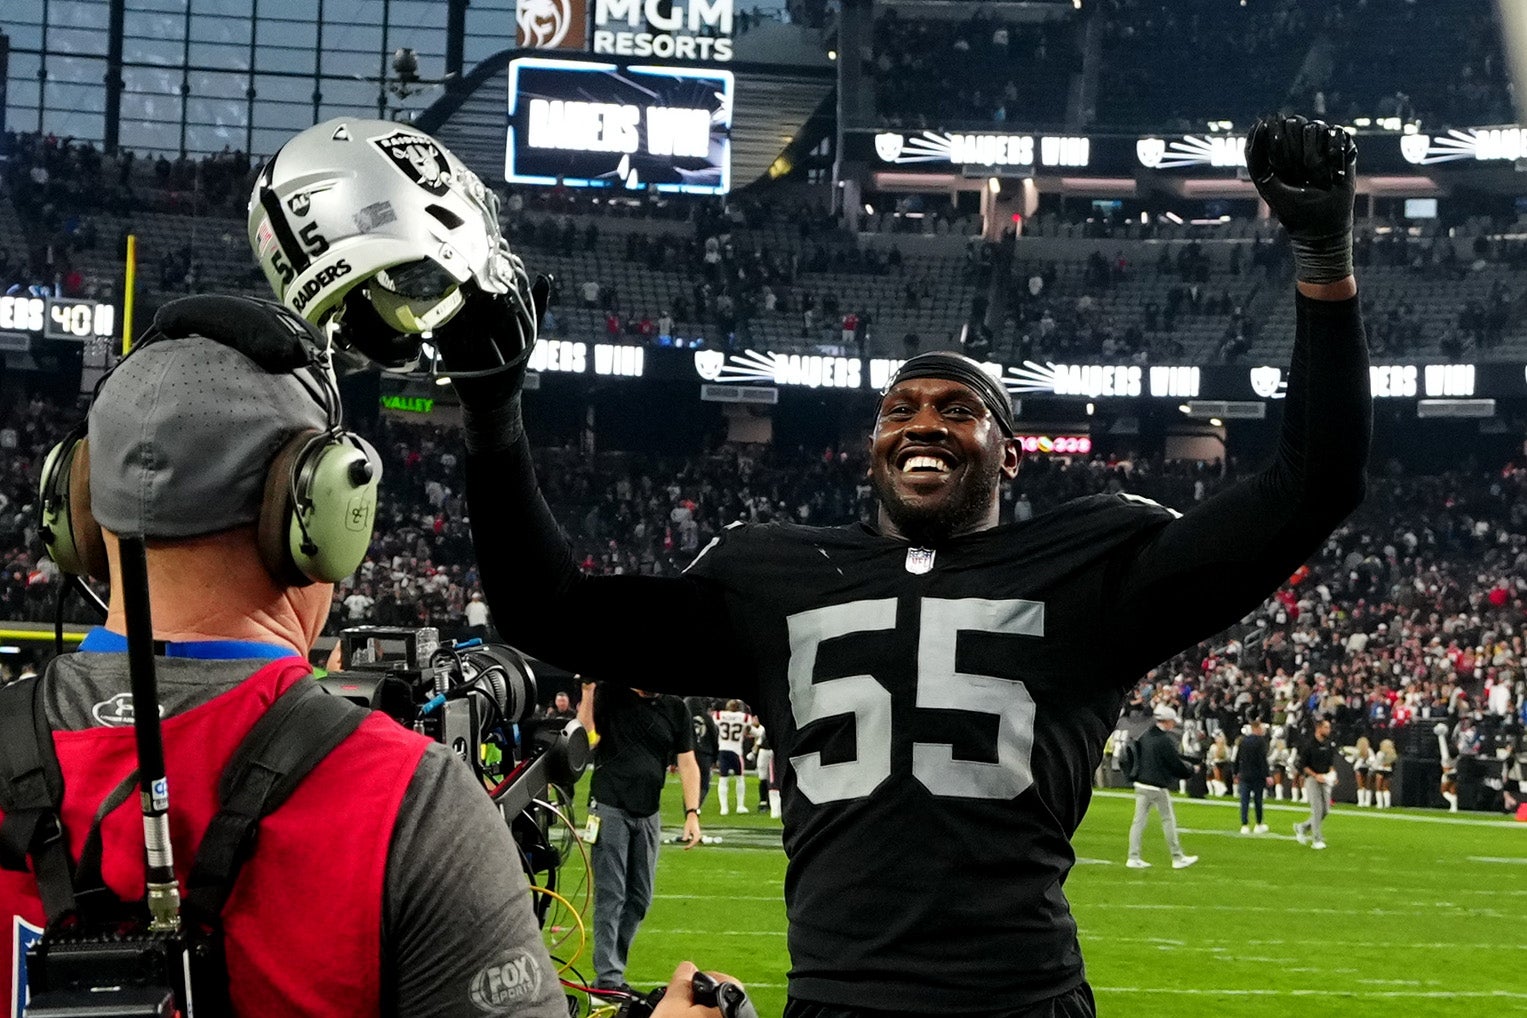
0 658 429 1018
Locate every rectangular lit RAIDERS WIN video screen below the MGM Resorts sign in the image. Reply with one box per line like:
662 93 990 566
504 56 734 194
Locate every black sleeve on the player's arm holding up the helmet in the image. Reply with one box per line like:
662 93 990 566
466 435 751 696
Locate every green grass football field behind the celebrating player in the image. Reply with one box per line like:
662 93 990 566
548 778 1527 1018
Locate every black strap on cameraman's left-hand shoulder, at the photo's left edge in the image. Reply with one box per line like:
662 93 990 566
0 678 75 922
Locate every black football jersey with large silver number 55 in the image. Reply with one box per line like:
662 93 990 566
689 496 1172 1013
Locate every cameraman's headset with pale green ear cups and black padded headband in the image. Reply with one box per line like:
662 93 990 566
38 296 382 586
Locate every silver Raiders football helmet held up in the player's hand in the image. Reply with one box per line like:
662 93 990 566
249 118 528 347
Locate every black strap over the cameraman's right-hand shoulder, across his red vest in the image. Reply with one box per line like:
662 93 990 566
185 678 370 926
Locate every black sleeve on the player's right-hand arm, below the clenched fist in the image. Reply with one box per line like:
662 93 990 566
1110 295 1373 675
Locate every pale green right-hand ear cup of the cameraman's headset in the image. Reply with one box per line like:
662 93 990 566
260 432 382 586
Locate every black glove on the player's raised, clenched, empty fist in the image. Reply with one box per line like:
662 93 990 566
1246 116 1358 282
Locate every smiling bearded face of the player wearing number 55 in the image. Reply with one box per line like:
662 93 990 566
870 379 1019 545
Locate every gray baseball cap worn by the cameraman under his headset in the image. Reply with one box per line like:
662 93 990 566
90 336 328 537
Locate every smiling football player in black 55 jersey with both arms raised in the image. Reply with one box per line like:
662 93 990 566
360 118 1371 1018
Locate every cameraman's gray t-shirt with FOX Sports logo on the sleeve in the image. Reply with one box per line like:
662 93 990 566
44 653 567 1018
